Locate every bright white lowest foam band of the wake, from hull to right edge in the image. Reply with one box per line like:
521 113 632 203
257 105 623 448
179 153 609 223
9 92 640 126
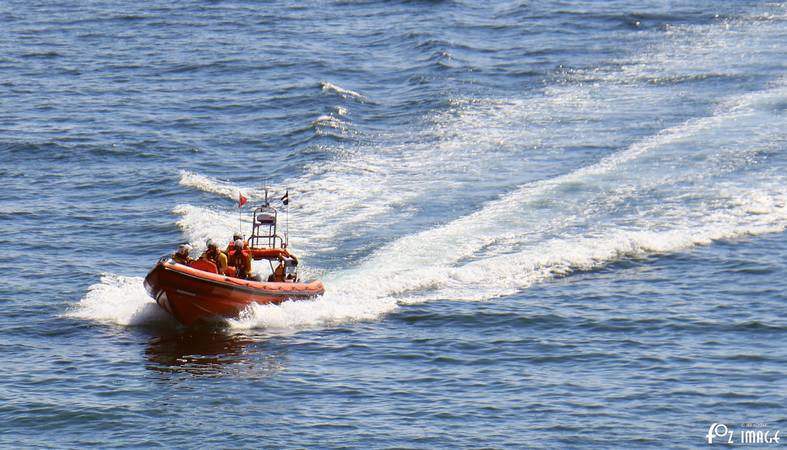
229 182 787 329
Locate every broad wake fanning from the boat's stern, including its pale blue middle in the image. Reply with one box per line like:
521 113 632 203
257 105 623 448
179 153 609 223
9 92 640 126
228 77 787 328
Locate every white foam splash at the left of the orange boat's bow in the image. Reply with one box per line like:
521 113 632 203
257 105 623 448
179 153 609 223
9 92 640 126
65 274 174 325
